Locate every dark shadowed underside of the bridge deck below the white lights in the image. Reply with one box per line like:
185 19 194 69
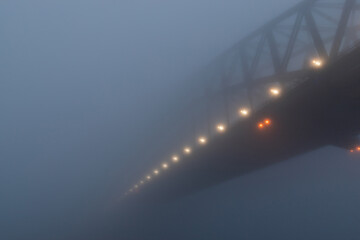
126 43 360 208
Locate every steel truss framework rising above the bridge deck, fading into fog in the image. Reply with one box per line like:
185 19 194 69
193 0 360 135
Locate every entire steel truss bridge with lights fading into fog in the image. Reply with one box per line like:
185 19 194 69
122 0 360 206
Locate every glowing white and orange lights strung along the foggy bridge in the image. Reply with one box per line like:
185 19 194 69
125 59 324 195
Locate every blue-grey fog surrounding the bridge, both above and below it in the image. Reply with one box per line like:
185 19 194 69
0 0 360 240
